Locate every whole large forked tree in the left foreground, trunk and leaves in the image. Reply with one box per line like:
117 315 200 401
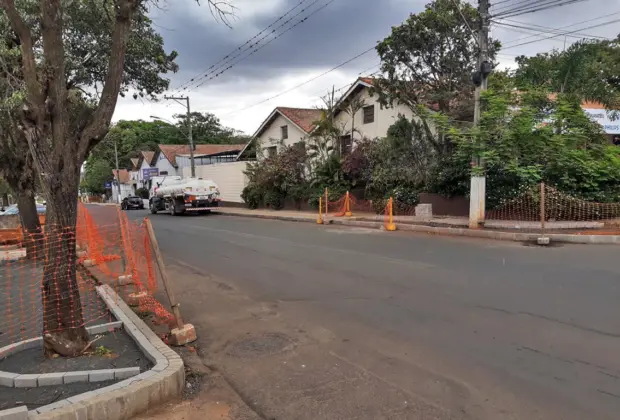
0 0 231 356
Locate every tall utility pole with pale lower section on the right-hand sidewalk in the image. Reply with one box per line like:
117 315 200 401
469 0 492 229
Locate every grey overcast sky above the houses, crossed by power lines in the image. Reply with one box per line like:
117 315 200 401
114 0 620 134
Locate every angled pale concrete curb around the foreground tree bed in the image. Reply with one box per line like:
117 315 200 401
18 285 185 420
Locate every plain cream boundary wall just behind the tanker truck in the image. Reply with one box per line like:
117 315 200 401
183 162 248 203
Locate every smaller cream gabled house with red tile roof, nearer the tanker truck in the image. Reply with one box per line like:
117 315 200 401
245 107 323 156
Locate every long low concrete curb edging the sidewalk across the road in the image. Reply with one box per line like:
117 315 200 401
213 211 620 245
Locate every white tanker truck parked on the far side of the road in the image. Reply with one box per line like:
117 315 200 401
149 176 220 216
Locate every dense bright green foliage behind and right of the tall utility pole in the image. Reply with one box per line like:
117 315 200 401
446 90 620 207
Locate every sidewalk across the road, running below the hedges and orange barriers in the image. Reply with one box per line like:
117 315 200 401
214 207 620 244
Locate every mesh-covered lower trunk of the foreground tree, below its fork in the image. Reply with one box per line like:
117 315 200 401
42 162 88 357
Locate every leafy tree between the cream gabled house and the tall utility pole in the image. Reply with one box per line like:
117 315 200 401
375 0 500 153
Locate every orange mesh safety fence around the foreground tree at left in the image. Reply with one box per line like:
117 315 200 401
0 204 174 347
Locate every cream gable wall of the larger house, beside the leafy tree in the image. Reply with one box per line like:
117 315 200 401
336 88 413 139
